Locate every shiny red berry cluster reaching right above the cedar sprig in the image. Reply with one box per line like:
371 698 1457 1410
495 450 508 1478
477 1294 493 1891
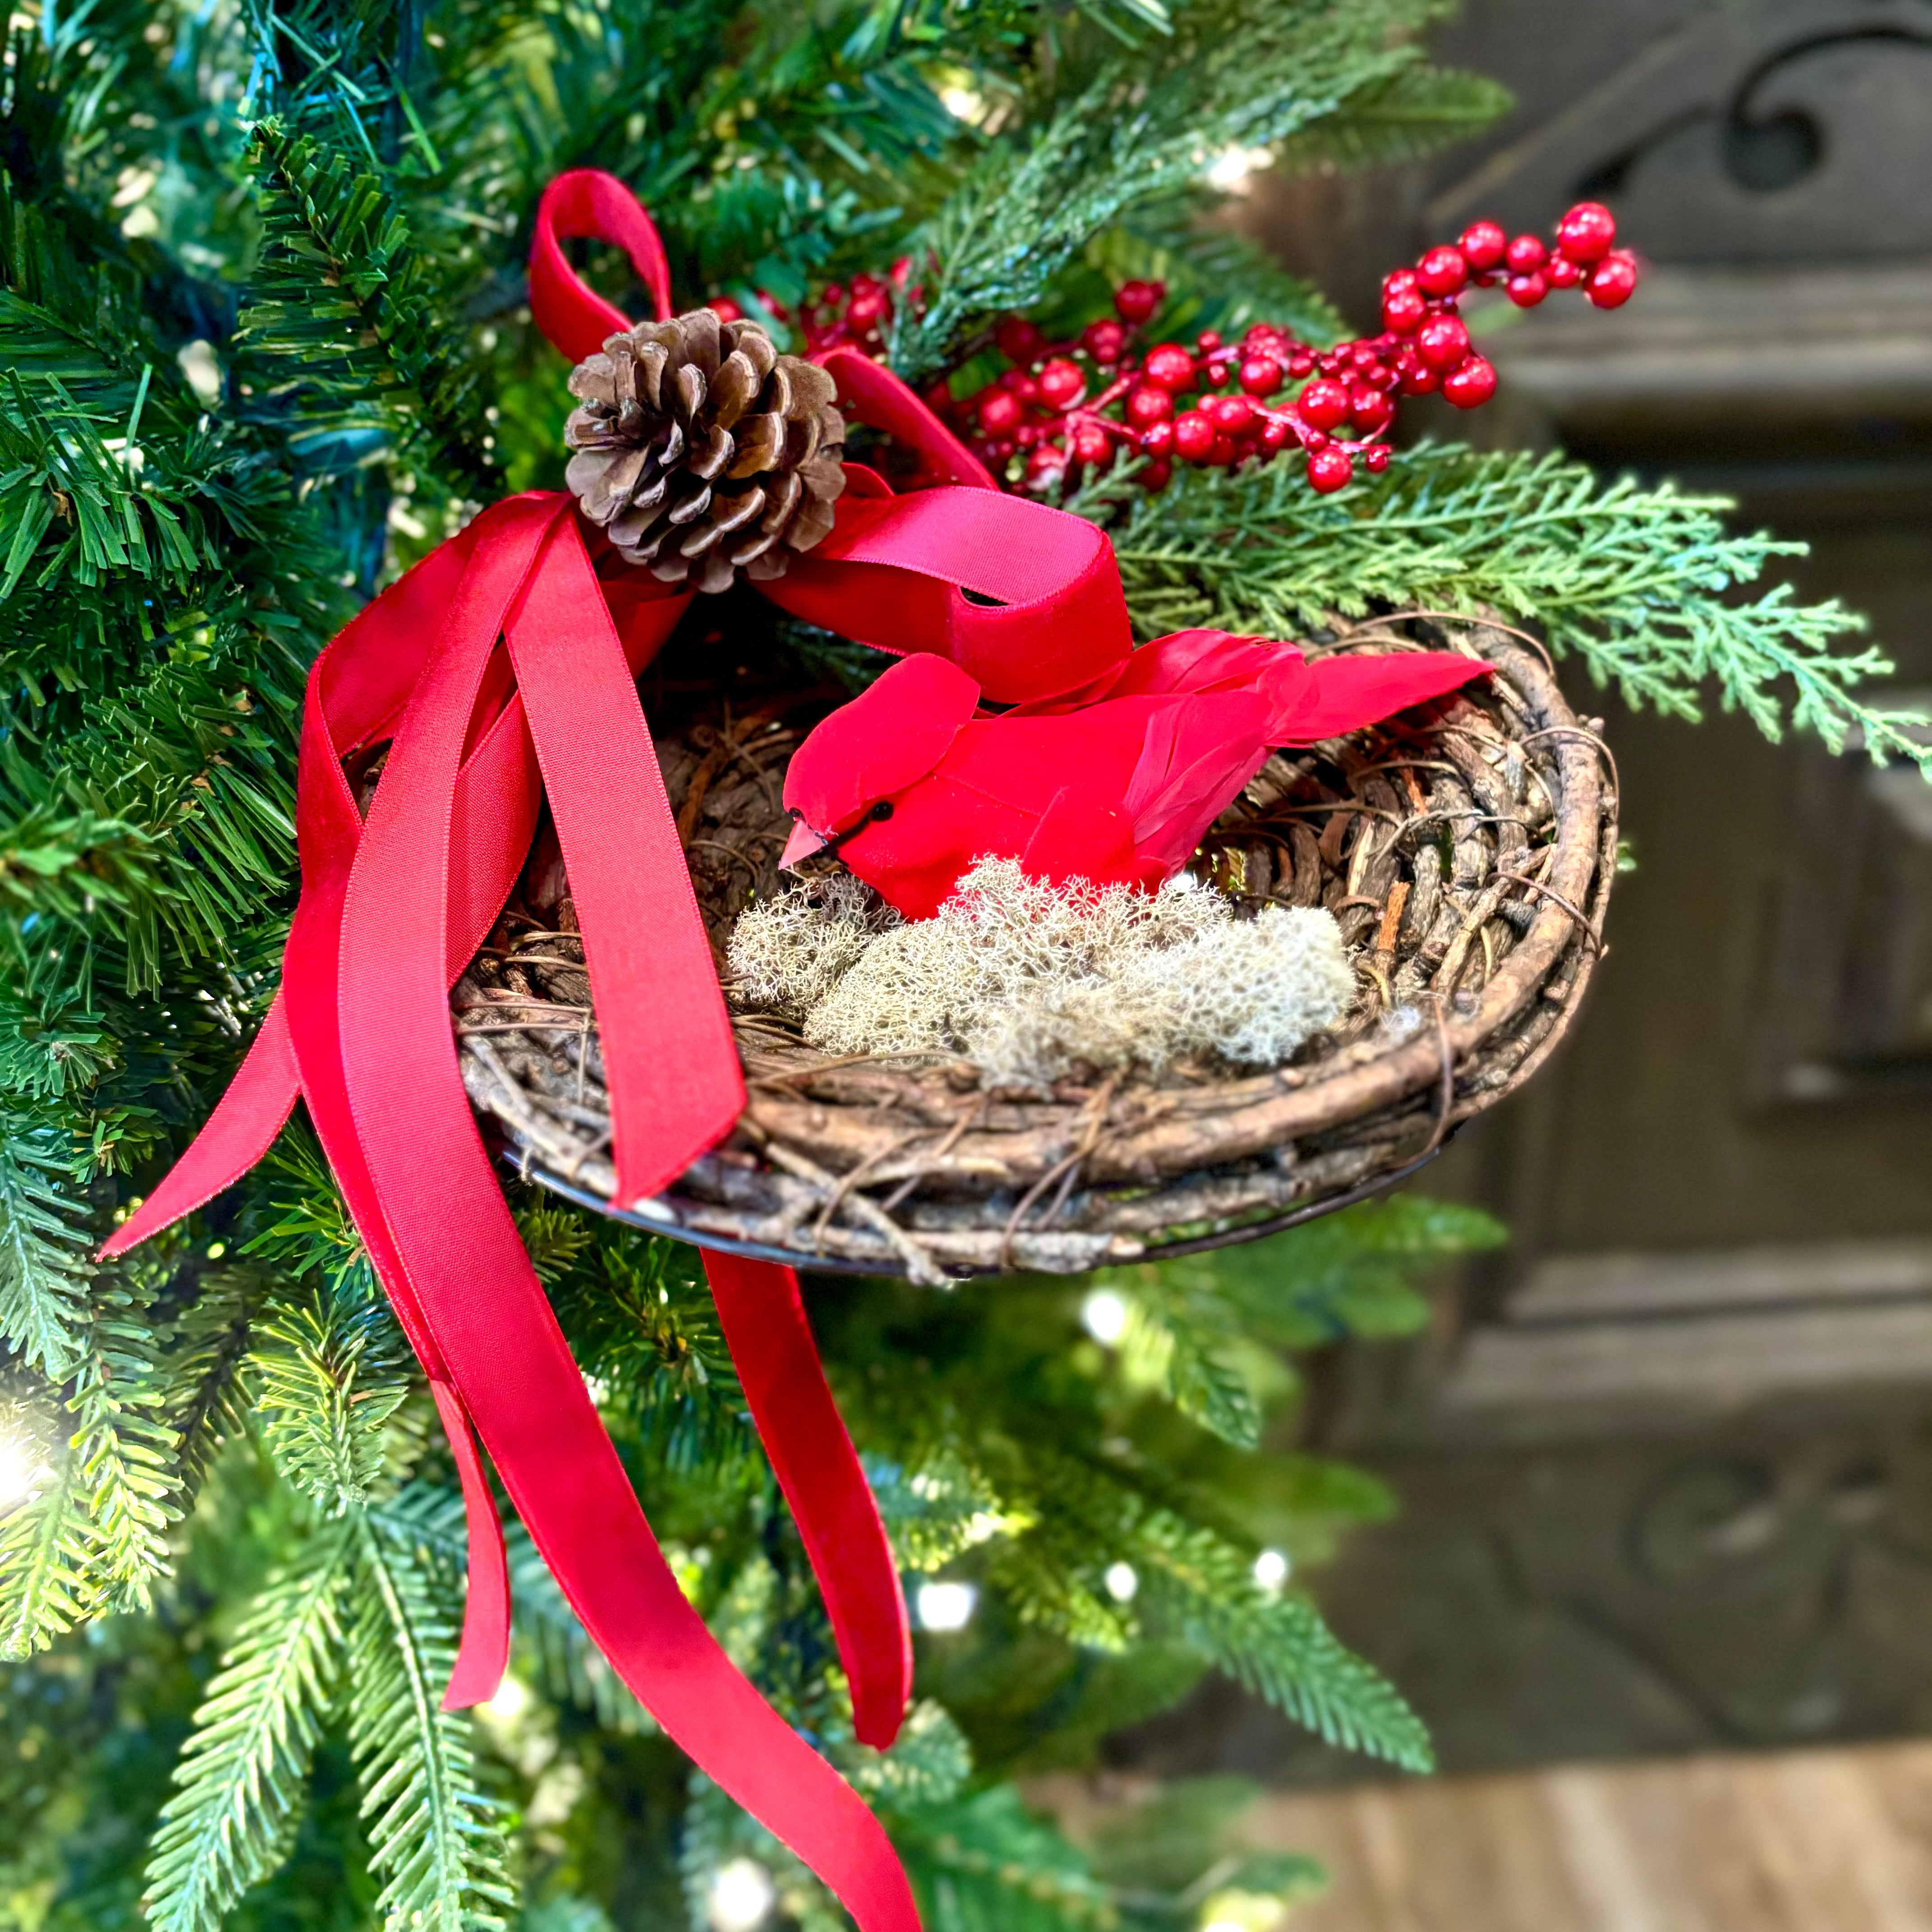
927 201 1637 492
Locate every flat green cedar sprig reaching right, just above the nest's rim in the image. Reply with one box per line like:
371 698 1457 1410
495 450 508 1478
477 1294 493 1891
1068 444 1932 769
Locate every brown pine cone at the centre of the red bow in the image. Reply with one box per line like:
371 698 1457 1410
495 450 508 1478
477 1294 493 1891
564 309 844 591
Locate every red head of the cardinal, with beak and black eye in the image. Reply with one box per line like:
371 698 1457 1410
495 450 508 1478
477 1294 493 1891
778 651 980 865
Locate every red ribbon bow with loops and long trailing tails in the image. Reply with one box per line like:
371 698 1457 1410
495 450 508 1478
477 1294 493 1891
102 170 1159 1932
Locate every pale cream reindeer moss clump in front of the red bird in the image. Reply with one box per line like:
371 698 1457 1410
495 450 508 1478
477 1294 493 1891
730 860 1354 1086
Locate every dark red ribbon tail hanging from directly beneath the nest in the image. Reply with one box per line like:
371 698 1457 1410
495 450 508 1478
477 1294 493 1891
705 1252 912 1750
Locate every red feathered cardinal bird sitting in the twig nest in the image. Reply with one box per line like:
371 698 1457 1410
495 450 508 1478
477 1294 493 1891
781 630 1486 920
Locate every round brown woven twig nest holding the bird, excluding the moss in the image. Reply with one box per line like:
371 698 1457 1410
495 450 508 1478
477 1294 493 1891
452 612 1617 1281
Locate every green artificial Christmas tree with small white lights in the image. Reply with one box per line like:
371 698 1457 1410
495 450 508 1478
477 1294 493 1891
0 0 1920 1932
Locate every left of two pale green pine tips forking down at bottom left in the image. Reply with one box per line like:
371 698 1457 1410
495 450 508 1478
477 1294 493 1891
145 1518 359 1932
